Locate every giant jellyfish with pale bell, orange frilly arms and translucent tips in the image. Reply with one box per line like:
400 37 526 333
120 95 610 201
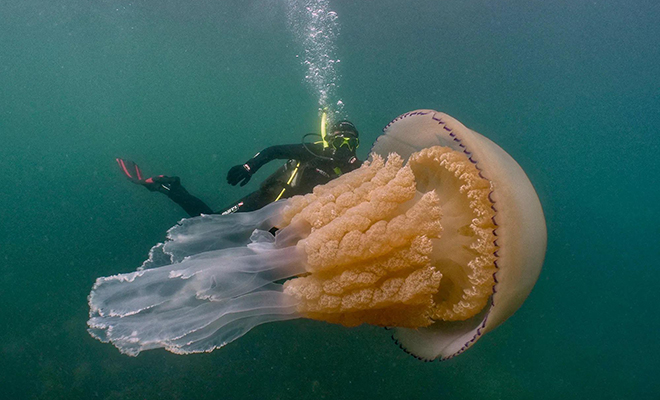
88 110 546 360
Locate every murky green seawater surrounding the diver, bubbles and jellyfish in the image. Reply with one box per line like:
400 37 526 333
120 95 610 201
0 0 660 399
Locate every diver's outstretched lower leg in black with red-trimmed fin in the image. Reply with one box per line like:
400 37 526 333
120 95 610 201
117 158 213 217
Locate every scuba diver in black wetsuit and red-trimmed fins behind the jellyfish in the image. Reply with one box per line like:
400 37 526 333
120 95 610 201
117 119 362 217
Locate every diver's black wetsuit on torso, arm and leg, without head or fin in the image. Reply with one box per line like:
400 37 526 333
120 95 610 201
159 143 362 217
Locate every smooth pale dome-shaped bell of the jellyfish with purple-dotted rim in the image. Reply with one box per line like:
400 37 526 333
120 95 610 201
372 110 547 359
